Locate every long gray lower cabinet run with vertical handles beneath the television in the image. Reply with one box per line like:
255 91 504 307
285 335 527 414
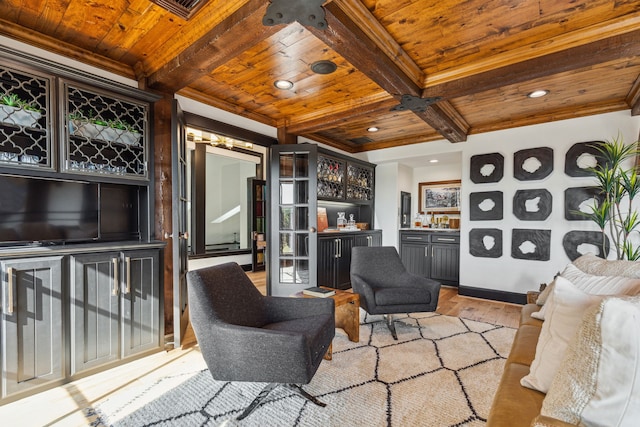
0 243 164 404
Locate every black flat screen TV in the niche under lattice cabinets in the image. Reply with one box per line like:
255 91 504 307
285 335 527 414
0 175 100 245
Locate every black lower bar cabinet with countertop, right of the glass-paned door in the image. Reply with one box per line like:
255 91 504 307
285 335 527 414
318 230 382 289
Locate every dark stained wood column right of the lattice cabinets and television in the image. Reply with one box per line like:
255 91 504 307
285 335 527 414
153 94 173 335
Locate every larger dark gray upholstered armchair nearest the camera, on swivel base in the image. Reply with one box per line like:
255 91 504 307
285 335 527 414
187 263 335 419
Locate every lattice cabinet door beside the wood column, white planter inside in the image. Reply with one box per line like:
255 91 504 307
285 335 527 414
62 82 149 180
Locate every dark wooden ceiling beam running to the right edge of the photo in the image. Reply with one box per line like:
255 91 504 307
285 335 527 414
421 30 640 99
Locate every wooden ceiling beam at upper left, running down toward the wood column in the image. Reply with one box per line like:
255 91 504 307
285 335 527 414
148 0 280 92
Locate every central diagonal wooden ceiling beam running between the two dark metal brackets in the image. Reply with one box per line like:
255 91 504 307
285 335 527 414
307 0 468 142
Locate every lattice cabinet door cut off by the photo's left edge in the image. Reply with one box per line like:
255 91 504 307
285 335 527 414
0 65 55 170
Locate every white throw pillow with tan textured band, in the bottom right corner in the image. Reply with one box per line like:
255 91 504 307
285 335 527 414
541 297 640 427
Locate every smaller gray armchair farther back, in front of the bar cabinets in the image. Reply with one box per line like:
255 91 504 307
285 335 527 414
351 246 440 340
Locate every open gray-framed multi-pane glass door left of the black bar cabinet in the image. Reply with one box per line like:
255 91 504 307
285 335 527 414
267 144 318 296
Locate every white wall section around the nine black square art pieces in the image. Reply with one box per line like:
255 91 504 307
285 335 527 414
460 111 640 293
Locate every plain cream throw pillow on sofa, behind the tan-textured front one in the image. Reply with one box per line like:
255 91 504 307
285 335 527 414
520 276 604 393
